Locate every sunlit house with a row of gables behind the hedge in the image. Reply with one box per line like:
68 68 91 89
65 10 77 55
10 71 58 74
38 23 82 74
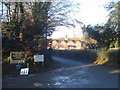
51 37 87 50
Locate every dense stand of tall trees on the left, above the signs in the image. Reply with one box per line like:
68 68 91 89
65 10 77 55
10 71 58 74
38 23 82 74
3 2 80 59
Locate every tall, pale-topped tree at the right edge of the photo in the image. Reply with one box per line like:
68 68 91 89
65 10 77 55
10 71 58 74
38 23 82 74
105 1 120 47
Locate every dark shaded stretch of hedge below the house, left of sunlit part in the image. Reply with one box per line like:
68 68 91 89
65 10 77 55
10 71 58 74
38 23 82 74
52 50 97 62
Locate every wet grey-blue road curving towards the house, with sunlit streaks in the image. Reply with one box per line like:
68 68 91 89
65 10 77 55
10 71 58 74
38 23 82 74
3 56 118 88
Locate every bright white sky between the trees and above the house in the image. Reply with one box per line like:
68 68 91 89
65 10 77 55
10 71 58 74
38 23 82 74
50 0 117 38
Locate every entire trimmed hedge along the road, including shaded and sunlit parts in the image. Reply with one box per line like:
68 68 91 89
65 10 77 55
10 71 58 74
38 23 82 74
52 50 120 66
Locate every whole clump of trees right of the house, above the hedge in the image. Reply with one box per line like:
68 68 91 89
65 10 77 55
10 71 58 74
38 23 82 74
83 2 120 48
